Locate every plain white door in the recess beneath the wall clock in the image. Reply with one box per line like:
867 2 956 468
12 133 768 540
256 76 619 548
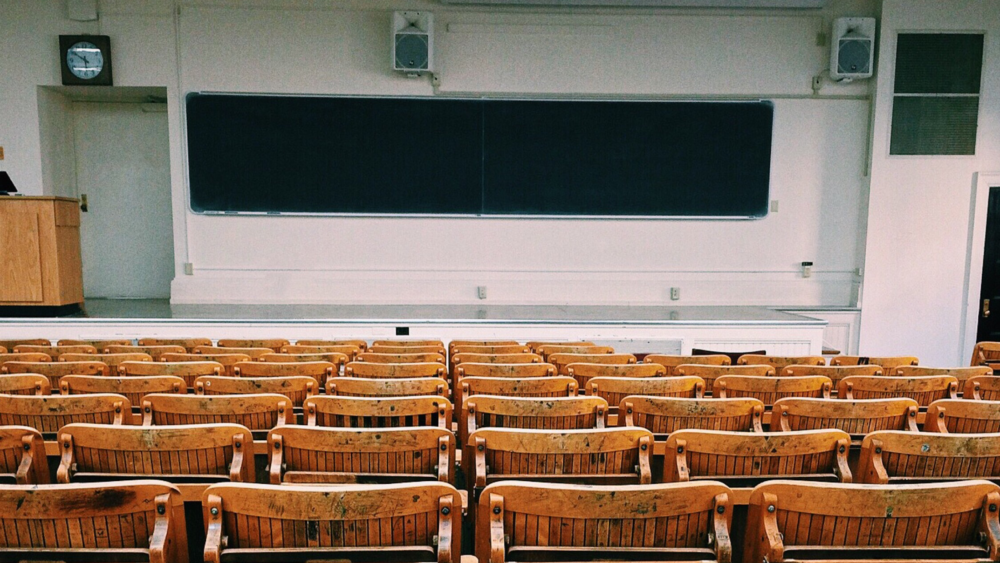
73 102 174 299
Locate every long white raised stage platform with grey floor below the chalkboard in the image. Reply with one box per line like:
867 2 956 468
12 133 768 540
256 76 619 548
0 300 827 355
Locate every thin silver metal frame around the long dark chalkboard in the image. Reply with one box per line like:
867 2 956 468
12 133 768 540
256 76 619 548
189 91 775 221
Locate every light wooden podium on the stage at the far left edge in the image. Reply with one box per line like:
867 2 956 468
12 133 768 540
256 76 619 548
0 196 83 306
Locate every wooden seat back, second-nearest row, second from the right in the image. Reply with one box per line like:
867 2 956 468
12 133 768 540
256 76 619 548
663 429 851 487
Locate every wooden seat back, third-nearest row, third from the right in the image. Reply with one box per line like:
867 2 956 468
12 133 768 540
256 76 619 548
618 395 764 435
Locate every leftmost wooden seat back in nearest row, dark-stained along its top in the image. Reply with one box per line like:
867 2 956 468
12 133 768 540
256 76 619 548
0 480 188 563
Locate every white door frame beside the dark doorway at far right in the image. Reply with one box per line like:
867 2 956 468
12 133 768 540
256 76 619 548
958 172 1000 361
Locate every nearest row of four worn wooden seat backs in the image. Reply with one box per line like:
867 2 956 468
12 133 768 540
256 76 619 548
0 480 1000 563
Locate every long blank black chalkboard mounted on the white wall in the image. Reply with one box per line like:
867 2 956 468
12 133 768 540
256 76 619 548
187 94 773 217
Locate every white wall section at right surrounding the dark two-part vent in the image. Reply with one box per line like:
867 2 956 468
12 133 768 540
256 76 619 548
861 0 1000 365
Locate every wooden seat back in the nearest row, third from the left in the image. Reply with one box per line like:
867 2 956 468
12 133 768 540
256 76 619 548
480 481 733 563
